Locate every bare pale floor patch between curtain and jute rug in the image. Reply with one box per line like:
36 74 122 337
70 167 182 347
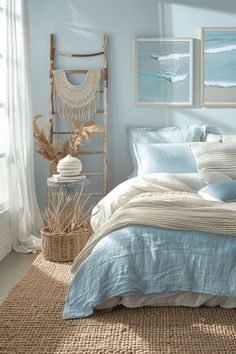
0 251 38 304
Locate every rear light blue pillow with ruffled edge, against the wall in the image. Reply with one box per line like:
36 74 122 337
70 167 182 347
127 125 206 177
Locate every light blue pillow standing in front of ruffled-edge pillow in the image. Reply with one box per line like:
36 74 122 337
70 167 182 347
133 143 197 176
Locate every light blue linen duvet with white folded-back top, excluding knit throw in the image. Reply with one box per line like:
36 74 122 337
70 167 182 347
63 172 236 319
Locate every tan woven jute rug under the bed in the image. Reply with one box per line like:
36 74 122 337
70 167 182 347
0 255 236 354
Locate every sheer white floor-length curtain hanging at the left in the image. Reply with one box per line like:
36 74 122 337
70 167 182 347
1 0 42 252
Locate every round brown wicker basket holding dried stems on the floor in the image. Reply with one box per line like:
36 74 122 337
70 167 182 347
41 223 92 262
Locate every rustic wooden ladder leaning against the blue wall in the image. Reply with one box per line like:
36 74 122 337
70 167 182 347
49 33 108 198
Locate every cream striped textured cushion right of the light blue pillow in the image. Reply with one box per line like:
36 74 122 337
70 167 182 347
191 143 236 179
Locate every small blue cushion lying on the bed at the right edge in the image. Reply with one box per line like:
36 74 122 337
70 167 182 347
198 180 236 202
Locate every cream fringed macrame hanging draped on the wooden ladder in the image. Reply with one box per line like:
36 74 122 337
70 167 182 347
53 69 101 123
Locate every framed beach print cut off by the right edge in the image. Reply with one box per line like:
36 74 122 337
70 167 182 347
201 27 236 107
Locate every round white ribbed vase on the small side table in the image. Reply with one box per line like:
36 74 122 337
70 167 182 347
57 155 82 177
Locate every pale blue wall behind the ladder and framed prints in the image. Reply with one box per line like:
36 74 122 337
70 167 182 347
28 0 236 208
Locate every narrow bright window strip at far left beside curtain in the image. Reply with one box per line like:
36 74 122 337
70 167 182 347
0 0 8 211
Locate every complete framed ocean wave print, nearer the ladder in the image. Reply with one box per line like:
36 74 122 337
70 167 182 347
135 37 193 107
